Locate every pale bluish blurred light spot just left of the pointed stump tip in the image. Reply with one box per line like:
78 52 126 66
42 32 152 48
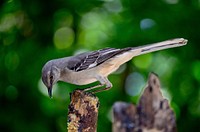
125 72 145 96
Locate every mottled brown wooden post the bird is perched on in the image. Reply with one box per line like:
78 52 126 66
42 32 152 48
68 90 99 132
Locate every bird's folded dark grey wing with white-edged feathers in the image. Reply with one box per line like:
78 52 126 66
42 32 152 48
67 48 132 72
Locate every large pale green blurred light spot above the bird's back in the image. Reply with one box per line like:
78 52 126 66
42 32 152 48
78 9 114 48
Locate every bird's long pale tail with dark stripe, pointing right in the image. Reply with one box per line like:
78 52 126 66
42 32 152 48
133 38 187 56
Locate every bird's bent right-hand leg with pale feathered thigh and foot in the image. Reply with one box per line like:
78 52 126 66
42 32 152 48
92 77 112 93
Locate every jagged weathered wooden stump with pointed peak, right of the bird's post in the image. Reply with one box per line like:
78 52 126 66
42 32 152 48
113 73 176 132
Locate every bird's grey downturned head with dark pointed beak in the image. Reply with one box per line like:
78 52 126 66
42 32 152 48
42 61 60 98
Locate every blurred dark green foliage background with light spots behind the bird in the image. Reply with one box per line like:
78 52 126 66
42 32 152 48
0 0 200 132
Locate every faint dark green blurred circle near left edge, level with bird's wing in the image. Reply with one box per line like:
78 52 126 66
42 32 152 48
5 51 20 71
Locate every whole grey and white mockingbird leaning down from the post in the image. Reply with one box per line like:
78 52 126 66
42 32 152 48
42 38 187 97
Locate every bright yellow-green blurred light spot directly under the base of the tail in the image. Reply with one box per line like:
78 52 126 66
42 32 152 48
133 54 152 69
